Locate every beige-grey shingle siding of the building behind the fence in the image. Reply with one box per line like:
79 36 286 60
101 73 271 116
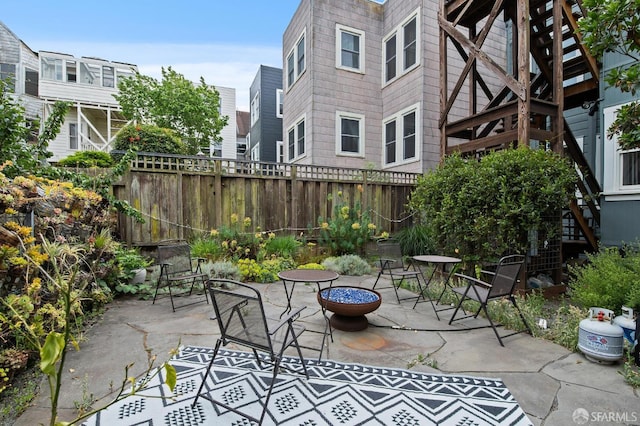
283 0 506 172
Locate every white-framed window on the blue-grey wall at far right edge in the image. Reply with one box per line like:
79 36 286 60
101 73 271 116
603 105 640 197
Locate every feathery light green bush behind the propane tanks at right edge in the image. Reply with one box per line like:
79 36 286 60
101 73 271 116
569 246 640 314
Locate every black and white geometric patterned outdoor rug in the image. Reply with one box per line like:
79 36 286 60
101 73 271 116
82 346 532 426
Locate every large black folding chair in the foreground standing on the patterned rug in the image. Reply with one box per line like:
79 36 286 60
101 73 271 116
192 279 309 424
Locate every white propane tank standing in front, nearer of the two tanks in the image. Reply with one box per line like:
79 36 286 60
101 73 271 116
578 307 623 363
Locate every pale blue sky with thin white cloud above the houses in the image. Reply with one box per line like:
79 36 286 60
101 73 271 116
0 0 300 111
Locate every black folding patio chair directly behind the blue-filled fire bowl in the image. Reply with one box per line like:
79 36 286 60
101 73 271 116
372 239 424 303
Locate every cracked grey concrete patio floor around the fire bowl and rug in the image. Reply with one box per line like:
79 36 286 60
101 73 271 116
15 276 640 426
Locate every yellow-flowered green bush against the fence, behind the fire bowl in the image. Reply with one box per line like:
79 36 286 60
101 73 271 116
318 191 376 256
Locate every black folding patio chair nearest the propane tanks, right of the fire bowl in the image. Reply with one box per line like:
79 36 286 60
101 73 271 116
449 255 531 346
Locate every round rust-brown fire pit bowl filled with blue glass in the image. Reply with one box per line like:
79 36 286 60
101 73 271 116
317 287 382 331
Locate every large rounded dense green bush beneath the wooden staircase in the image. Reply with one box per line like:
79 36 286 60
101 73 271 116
409 147 577 261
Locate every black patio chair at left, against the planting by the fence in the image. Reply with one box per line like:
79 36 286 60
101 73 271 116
152 242 209 312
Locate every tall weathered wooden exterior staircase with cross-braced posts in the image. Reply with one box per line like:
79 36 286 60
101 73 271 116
439 0 601 255
